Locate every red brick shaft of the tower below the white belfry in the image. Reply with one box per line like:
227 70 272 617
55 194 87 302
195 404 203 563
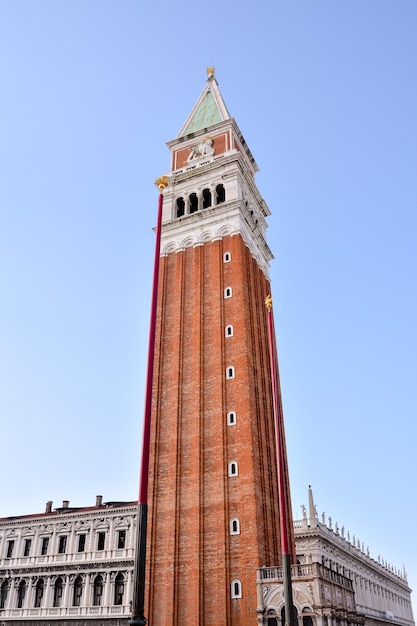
145 236 294 626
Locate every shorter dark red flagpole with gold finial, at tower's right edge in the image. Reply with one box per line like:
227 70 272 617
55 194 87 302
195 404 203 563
265 295 295 626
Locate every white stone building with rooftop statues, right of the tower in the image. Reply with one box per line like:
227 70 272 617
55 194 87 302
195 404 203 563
257 488 414 626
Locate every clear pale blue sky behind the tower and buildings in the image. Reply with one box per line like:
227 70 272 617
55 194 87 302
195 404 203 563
0 0 417 608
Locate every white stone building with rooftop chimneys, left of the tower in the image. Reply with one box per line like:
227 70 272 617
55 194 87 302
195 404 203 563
0 496 137 626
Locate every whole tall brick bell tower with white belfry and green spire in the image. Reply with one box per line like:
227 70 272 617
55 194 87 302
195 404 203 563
145 69 294 626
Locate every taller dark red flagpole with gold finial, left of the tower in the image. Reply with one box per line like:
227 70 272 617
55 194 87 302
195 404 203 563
130 176 168 626
